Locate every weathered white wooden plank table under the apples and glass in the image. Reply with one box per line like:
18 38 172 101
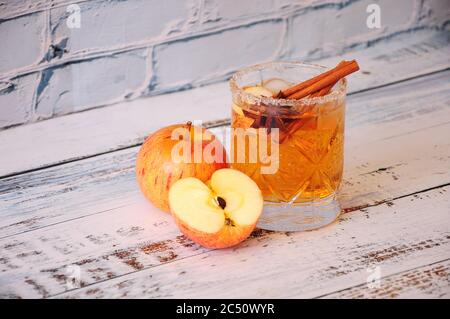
0 31 450 298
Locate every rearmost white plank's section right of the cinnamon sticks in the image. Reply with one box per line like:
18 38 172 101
320 30 450 92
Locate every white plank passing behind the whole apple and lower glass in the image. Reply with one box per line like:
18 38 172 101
0 71 450 238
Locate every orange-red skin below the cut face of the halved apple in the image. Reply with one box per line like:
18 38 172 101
172 214 256 249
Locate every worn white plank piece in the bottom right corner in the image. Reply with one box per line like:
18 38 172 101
321 259 450 299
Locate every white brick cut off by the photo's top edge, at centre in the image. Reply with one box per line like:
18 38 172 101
202 0 276 23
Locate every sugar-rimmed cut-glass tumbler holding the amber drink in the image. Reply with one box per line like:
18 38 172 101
230 62 346 231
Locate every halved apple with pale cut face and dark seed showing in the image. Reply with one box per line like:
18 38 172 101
169 168 263 248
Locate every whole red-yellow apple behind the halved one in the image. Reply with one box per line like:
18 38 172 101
136 122 228 212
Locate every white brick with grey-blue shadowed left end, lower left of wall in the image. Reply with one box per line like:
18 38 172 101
36 50 147 118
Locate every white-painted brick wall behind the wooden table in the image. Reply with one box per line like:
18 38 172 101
0 0 450 129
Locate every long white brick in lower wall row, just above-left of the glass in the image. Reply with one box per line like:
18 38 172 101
154 21 284 90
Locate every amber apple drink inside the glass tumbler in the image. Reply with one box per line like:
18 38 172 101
231 87 345 202
